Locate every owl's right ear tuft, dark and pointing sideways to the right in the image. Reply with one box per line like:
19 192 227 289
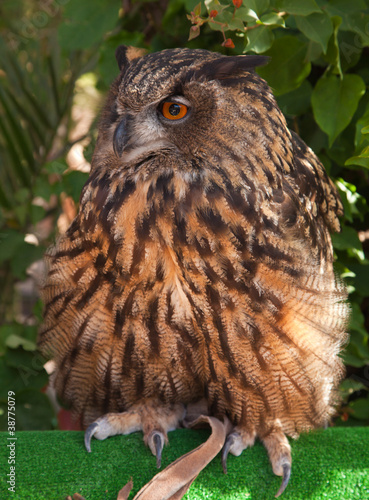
196 56 269 80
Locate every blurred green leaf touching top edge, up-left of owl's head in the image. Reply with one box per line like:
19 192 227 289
59 0 121 50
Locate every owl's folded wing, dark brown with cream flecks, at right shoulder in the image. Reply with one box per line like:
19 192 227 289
291 131 343 232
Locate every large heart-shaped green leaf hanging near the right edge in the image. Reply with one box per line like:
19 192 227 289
311 74 365 146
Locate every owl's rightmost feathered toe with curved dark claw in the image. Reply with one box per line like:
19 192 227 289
262 429 292 498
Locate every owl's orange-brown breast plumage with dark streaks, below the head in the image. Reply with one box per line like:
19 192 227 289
40 166 342 415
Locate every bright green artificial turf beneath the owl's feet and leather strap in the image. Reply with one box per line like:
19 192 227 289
0 427 369 500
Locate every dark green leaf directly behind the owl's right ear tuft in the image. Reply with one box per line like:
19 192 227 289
257 35 311 95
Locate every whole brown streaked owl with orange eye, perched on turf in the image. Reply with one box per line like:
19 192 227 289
39 46 348 498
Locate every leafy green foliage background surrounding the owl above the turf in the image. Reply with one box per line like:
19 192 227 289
0 0 369 430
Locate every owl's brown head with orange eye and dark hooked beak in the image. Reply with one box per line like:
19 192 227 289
93 46 280 180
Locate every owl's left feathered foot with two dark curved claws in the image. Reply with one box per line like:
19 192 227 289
85 400 185 468
